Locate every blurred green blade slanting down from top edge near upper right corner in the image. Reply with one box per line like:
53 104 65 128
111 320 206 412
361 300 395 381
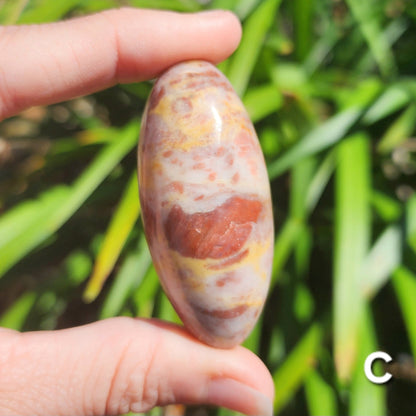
347 0 397 77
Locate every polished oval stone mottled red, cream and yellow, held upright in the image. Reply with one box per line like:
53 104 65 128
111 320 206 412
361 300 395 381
138 61 273 348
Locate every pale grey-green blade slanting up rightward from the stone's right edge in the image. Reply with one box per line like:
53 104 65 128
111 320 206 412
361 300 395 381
268 108 362 180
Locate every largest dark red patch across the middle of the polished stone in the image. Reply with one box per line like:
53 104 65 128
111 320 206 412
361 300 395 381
164 196 263 259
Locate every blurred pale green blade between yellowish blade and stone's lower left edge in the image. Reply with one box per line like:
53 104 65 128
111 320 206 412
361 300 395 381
100 235 152 319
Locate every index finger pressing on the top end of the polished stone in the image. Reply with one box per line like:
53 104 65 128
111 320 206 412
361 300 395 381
0 8 241 120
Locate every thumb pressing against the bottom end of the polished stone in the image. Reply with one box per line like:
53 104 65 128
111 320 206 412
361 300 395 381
0 318 274 415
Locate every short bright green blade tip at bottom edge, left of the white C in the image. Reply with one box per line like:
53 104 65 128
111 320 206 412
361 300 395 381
305 370 339 416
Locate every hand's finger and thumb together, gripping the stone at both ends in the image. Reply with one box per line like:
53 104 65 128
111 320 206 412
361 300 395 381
0 9 274 415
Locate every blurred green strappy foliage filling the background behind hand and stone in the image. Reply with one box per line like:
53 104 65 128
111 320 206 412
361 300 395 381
0 0 416 416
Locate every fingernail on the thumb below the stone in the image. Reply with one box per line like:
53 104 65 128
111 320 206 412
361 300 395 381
208 378 273 416
